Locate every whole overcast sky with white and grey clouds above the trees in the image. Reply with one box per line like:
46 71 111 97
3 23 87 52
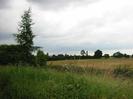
0 0 133 54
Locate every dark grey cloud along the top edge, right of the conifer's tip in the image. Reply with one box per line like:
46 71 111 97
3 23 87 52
27 0 99 10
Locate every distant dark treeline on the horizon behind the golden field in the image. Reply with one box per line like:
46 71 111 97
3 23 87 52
48 50 133 61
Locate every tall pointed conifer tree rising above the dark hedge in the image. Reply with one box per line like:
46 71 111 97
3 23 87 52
14 9 35 63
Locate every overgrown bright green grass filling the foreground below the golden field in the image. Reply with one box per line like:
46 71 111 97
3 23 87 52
0 66 133 99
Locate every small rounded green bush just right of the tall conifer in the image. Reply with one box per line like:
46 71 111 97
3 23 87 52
36 50 47 66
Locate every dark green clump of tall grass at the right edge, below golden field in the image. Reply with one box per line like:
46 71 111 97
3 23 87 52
113 65 133 77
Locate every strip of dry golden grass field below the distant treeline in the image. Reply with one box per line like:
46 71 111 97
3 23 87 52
48 58 133 69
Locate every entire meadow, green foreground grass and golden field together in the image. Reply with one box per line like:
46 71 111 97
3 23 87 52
0 59 133 99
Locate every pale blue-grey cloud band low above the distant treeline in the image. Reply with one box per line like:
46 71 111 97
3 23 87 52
34 37 132 54
